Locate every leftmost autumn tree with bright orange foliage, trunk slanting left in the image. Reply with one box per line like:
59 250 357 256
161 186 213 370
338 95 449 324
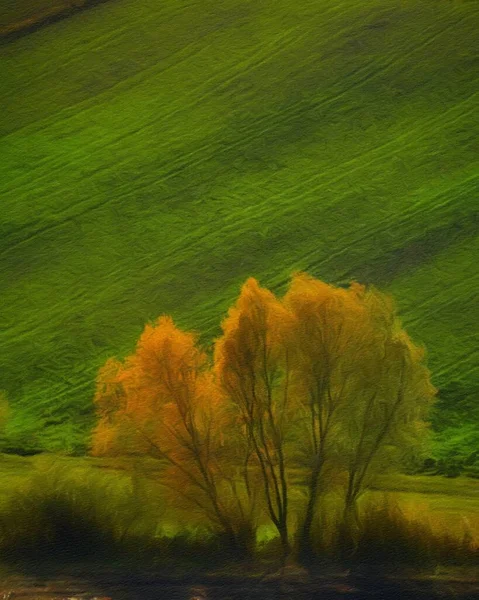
92 317 255 549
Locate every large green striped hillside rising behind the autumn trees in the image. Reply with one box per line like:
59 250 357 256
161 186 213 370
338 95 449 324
0 0 479 449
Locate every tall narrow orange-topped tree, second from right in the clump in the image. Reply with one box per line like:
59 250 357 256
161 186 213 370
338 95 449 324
284 274 364 554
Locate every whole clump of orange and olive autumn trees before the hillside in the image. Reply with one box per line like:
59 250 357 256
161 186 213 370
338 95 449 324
91 273 435 556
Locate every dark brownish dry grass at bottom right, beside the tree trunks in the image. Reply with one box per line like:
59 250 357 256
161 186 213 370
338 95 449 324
306 493 479 568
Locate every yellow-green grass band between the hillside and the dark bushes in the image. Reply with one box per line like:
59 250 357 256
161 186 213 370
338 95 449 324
0 455 479 547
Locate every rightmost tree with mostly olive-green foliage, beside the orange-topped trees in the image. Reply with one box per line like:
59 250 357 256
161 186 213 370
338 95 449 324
339 326 436 521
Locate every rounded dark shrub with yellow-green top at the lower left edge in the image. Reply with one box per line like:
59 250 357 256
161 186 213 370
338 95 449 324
0 457 149 560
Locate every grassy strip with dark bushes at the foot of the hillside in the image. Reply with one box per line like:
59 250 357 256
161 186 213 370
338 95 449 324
0 455 479 579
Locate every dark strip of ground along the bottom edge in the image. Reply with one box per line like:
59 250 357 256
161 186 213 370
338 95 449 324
0 572 479 600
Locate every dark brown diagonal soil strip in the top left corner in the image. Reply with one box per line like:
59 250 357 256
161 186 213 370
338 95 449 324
0 0 115 44
